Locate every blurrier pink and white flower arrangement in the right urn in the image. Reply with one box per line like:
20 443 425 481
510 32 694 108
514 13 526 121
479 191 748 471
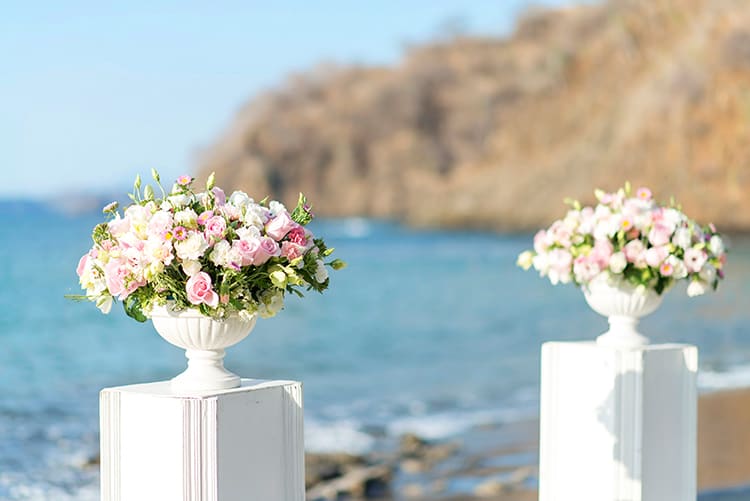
517 184 726 297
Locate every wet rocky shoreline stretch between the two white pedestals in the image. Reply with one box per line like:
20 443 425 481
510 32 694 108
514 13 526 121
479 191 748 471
305 421 538 501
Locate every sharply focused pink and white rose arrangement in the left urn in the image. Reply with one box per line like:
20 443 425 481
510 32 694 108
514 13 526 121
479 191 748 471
76 170 345 322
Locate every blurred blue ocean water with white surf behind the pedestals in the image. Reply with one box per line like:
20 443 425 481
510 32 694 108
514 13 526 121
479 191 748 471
0 204 750 501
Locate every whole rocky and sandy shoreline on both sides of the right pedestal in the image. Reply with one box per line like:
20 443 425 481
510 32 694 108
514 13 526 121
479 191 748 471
305 389 750 501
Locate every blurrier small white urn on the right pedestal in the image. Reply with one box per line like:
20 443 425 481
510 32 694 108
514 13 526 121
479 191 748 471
583 278 662 349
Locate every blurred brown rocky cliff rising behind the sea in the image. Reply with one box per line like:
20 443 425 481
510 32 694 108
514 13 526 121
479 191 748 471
199 0 750 230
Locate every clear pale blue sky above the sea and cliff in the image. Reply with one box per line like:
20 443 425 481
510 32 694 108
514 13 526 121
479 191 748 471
0 0 570 199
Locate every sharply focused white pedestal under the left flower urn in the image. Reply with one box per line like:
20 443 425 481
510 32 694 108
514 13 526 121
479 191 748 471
100 379 305 501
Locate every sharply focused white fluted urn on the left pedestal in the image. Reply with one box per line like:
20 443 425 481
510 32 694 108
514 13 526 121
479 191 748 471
151 306 258 392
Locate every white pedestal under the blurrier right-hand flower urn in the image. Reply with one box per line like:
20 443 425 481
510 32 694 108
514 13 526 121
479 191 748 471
539 342 698 501
